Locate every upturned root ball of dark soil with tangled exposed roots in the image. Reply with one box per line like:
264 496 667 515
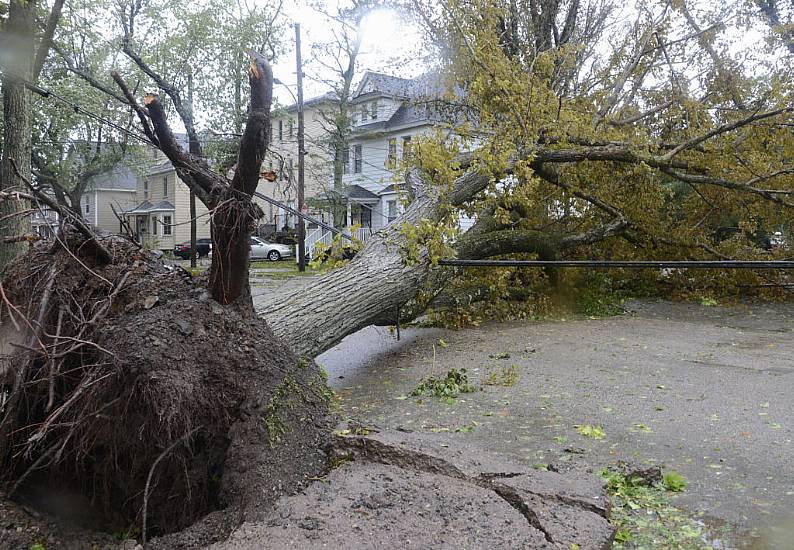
0 237 329 548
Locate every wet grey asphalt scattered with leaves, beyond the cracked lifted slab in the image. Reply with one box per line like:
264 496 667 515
317 302 794 548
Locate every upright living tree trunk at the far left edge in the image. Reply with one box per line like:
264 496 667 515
0 0 36 271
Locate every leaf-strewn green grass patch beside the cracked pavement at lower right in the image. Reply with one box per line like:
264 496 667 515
601 468 712 550
